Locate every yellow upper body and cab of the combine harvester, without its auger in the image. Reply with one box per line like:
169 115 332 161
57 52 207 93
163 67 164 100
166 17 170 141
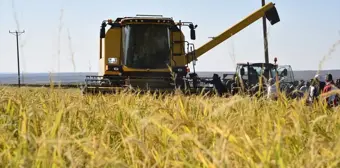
100 15 197 75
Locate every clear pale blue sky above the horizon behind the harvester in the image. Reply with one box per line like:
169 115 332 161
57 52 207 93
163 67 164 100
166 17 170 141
0 0 340 72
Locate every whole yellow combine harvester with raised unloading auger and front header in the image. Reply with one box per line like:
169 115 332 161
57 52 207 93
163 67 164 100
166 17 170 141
84 3 280 93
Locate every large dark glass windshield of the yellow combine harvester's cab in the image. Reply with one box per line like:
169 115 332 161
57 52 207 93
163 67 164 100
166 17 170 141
122 24 171 69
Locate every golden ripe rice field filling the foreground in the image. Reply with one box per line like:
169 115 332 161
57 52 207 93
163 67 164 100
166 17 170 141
0 87 340 168
